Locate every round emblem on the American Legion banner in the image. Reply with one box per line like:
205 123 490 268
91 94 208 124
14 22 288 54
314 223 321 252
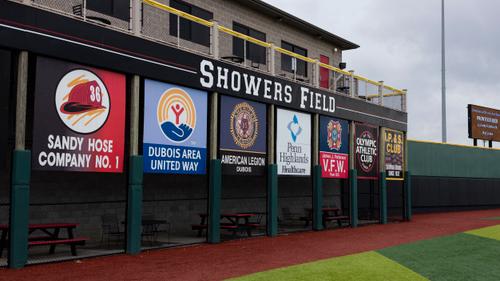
230 102 259 149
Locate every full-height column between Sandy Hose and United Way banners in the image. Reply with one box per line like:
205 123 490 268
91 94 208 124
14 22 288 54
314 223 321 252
126 75 144 254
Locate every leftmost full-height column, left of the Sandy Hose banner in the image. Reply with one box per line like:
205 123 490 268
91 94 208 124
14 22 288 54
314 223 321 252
9 51 31 268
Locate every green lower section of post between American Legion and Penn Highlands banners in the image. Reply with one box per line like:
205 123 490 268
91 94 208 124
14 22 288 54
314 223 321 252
267 164 278 237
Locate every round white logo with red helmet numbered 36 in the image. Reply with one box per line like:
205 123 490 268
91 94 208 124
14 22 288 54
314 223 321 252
55 69 111 134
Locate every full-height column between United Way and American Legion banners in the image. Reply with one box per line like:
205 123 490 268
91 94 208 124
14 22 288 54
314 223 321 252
208 92 222 244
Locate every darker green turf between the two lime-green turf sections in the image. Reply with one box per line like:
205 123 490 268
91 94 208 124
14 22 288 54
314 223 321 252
378 233 500 281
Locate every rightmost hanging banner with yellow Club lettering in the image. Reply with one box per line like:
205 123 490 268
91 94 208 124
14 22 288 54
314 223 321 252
384 129 405 180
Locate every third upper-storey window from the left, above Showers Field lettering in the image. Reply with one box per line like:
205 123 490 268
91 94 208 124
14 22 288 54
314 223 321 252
233 23 266 64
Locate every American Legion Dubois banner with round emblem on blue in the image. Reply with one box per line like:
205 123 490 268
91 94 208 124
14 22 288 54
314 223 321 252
219 96 267 176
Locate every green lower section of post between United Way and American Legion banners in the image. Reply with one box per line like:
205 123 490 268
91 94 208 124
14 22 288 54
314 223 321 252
208 159 222 244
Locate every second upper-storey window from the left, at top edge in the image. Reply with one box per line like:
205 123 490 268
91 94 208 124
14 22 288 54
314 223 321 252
170 0 214 47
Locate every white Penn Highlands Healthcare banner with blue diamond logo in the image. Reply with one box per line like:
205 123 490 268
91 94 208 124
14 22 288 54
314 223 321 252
276 109 311 176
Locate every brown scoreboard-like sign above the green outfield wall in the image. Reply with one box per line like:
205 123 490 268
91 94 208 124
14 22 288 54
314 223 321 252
467 104 500 141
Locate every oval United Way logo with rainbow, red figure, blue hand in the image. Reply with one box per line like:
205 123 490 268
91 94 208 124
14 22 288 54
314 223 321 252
157 88 196 143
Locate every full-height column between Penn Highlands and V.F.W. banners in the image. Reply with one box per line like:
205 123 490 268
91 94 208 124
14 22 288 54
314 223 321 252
312 113 323 230
